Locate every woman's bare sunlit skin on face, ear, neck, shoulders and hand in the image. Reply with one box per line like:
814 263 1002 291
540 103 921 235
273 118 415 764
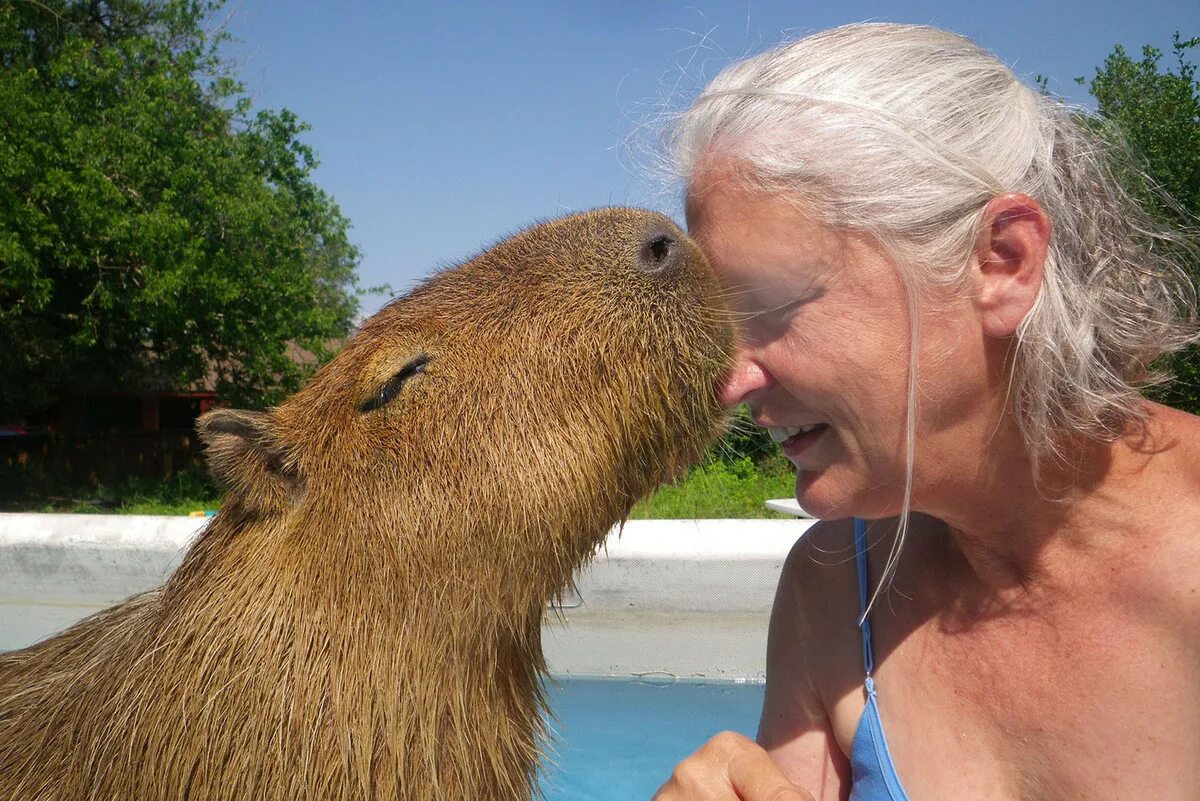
655 153 1200 801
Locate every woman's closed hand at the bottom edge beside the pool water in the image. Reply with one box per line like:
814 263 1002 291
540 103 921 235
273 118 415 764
653 731 812 801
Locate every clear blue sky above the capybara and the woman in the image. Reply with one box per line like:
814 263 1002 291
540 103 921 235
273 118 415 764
224 0 1200 313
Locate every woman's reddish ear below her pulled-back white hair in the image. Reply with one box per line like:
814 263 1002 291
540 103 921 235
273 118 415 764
972 193 1050 337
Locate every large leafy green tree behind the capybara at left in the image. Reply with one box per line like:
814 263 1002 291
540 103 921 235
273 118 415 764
0 0 362 420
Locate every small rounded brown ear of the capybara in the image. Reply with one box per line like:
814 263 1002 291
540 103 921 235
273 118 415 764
196 409 298 510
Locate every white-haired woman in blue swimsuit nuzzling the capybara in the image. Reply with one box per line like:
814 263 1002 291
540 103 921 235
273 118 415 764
656 25 1200 801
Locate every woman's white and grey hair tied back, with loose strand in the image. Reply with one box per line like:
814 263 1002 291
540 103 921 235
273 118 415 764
668 24 1195 599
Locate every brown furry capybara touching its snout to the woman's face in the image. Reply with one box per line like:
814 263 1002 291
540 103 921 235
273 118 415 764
0 209 732 801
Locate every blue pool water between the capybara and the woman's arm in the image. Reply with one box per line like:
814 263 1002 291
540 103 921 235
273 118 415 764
541 679 764 801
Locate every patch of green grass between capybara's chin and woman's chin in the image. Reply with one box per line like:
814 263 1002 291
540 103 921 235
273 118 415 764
629 457 796 519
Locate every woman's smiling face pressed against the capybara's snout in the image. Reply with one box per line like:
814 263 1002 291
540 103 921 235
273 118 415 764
686 159 984 518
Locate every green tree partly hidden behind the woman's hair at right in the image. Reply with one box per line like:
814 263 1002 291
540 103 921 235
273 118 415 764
1076 32 1200 414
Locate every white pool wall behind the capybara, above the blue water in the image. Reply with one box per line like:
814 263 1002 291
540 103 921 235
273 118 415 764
0 513 812 681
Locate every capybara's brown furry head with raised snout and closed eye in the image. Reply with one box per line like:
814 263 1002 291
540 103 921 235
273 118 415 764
200 209 731 604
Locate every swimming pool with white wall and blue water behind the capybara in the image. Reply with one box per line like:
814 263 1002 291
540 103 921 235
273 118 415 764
0 513 811 801
